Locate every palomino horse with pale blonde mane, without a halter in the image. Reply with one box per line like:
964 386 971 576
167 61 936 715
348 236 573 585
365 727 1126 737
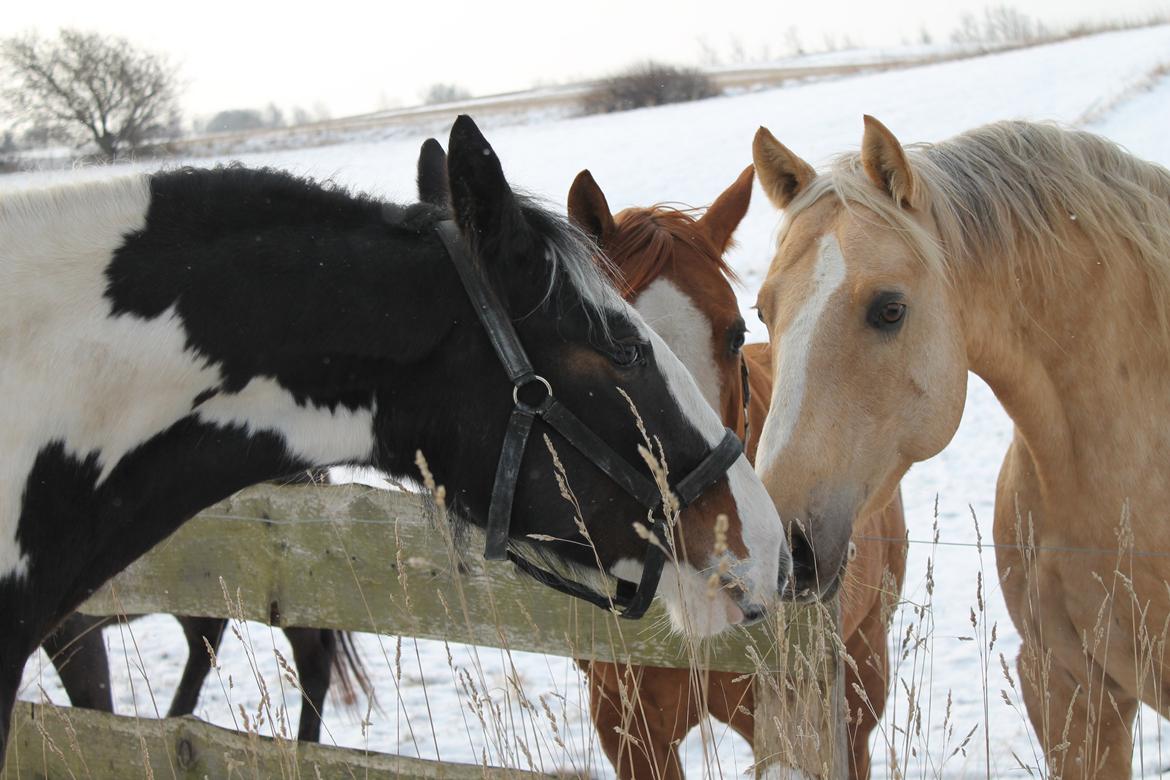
753 117 1170 778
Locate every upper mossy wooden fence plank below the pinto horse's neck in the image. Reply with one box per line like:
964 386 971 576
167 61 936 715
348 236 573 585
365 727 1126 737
83 485 823 671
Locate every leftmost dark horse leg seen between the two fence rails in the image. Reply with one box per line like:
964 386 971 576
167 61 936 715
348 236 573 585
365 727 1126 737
41 612 113 712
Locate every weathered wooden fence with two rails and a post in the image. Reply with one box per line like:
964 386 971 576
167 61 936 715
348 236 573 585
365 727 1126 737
0 485 846 780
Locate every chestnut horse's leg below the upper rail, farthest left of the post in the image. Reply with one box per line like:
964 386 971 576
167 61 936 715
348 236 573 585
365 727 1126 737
577 661 700 780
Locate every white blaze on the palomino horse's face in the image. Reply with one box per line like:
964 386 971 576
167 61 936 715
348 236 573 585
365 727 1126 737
756 234 845 474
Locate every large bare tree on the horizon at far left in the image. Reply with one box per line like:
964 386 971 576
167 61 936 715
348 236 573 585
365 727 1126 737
0 29 179 159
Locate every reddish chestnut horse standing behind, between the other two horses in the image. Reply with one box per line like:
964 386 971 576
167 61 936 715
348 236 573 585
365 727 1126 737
569 166 906 778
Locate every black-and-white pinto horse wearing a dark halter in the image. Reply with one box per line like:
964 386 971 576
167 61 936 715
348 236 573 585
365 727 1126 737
0 117 790 762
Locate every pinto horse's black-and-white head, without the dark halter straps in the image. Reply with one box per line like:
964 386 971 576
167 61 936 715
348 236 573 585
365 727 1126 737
420 118 790 634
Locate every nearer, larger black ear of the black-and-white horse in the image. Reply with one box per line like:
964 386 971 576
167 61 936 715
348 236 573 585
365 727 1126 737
447 115 524 243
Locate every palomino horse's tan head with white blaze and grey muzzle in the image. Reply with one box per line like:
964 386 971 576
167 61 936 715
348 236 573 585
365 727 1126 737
752 117 966 595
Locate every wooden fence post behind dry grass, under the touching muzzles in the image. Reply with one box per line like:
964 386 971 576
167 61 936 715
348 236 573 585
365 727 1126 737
753 599 849 780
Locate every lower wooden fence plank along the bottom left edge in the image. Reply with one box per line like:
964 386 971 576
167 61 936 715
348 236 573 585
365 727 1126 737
0 702 553 780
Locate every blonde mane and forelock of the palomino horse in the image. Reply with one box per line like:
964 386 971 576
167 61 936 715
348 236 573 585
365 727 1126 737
780 122 1170 334
